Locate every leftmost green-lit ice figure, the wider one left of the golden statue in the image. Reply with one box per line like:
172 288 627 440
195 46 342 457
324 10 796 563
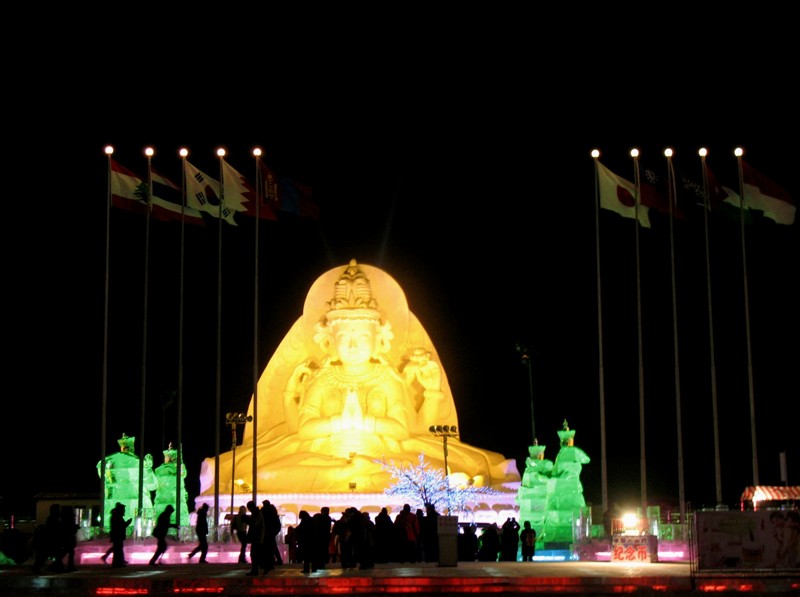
97 433 157 533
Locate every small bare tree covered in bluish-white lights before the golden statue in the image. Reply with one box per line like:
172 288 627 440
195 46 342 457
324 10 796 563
375 454 500 515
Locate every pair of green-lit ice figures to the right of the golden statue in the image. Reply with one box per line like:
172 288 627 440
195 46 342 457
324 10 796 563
516 420 589 548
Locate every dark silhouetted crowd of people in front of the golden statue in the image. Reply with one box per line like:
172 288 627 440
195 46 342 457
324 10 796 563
26 500 536 576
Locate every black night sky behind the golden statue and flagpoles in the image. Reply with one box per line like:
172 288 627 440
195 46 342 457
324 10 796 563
0 14 800 515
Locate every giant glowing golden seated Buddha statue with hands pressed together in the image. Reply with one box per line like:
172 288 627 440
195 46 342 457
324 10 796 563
200 260 520 495
